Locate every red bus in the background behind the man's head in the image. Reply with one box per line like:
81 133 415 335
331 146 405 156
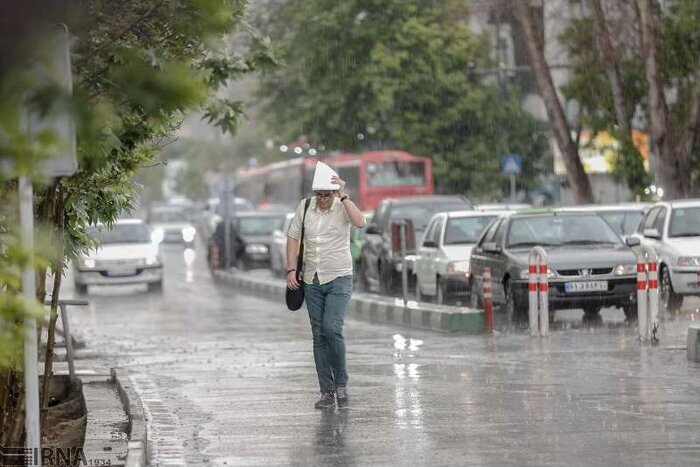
234 151 433 211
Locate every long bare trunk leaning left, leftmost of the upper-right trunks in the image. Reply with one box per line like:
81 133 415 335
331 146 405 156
511 0 594 204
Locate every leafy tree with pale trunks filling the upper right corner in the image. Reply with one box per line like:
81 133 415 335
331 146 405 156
562 0 700 198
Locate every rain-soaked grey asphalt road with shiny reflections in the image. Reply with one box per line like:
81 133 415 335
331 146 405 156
64 246 700 465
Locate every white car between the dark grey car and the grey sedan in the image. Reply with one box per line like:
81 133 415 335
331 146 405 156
415 211 502 304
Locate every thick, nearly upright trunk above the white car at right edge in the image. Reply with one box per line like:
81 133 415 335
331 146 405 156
637 0 697 199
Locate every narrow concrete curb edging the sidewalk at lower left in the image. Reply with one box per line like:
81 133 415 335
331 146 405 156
111 368 148 467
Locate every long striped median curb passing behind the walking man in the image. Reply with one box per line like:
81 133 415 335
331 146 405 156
214 270 486 334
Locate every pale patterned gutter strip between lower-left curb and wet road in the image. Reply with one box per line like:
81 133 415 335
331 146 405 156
129 373 187 466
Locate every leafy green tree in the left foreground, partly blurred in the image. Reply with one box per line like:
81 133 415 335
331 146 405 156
0 0 274 446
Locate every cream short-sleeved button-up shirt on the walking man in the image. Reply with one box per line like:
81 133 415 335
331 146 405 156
287 196 352 284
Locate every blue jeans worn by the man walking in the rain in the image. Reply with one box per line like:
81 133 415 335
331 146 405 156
304 276 352 393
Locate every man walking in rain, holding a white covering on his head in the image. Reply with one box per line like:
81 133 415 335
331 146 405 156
287 162 365 409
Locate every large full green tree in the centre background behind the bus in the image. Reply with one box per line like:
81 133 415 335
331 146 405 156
260 0 545 199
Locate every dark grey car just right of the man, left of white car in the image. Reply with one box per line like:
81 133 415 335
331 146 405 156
358 196 472 294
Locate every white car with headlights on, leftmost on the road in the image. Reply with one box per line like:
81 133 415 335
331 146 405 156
73 219 163 293
